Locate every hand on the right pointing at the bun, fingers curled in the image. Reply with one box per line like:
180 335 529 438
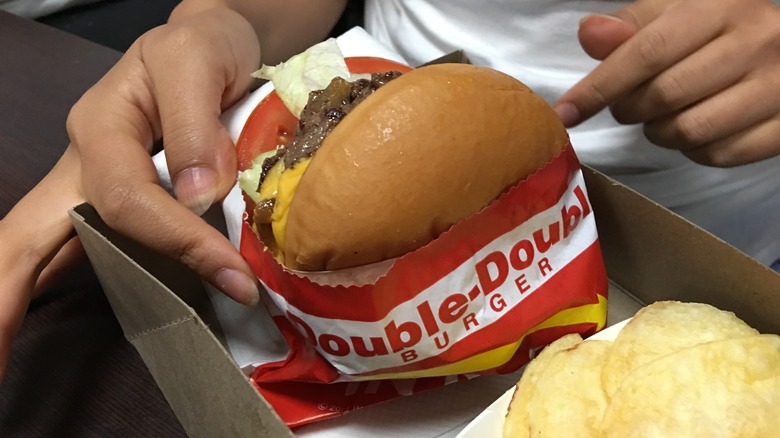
555 0 780 167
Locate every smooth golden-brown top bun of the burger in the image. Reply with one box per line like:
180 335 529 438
284 64 568 271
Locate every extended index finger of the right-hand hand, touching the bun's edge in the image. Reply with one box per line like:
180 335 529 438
555 0 720 127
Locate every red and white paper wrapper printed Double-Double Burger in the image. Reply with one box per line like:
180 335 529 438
212 26 607 427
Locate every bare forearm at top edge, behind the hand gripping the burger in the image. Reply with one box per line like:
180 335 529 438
169 0 347 64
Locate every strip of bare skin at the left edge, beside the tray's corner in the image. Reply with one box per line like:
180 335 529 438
0 148 84 380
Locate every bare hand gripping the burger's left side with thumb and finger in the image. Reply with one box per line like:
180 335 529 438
67 8 259 305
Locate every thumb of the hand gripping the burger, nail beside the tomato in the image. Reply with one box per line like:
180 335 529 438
138 13 260 219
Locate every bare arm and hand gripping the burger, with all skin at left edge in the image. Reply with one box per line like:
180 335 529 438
0 0 346 379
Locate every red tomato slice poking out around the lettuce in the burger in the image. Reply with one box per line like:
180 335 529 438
236 56 412 171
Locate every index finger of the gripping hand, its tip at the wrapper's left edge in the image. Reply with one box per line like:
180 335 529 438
69 56 259 305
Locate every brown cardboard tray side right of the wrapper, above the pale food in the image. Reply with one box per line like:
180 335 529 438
583 167 780 334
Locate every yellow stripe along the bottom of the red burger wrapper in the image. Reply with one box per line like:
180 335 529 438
366 295 607 380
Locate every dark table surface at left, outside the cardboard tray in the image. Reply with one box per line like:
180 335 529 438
0 11 184 437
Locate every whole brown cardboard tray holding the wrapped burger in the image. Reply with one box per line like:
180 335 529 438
71 163 780 437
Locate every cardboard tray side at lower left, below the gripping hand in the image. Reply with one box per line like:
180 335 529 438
70 204 292 437
